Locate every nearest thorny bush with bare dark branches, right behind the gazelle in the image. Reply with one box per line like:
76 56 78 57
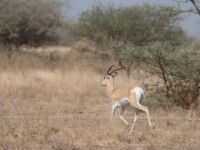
110 42 200 108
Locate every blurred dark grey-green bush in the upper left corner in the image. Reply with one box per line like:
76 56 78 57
0 0 61 46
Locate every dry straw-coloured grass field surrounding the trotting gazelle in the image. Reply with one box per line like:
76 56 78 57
0 46 200 150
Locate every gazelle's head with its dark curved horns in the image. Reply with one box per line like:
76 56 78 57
101 61 122 86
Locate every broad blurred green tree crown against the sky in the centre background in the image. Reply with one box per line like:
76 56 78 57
74 5 184 45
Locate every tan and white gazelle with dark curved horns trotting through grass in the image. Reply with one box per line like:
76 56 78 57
101 62 154 135
